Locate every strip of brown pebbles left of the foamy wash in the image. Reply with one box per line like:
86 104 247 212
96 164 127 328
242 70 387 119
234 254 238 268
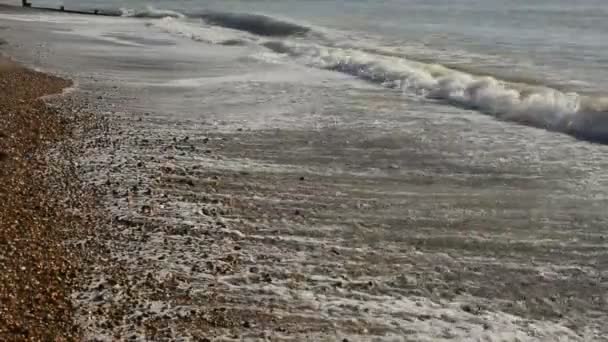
0 58 93 341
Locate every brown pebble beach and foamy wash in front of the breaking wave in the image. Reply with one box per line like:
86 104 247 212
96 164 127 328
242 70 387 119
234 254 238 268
0 5 608 342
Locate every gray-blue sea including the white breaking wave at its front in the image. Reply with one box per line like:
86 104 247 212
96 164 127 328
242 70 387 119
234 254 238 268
21 0 608 141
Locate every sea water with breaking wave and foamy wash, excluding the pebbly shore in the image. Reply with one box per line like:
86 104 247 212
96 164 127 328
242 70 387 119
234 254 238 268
0 0 608 341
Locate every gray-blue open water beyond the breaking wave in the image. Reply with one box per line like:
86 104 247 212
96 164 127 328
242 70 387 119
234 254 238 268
35 0 608 93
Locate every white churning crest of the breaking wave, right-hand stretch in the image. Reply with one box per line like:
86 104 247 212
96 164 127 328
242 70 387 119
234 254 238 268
263 41 608 143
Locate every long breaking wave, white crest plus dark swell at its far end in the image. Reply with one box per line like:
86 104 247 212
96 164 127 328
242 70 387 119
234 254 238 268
17 1 608 144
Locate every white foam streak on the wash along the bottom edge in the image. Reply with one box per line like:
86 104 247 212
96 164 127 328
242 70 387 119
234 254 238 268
240 284 585 341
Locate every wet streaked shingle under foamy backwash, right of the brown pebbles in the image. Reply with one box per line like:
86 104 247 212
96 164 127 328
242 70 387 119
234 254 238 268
64 95 606 341
